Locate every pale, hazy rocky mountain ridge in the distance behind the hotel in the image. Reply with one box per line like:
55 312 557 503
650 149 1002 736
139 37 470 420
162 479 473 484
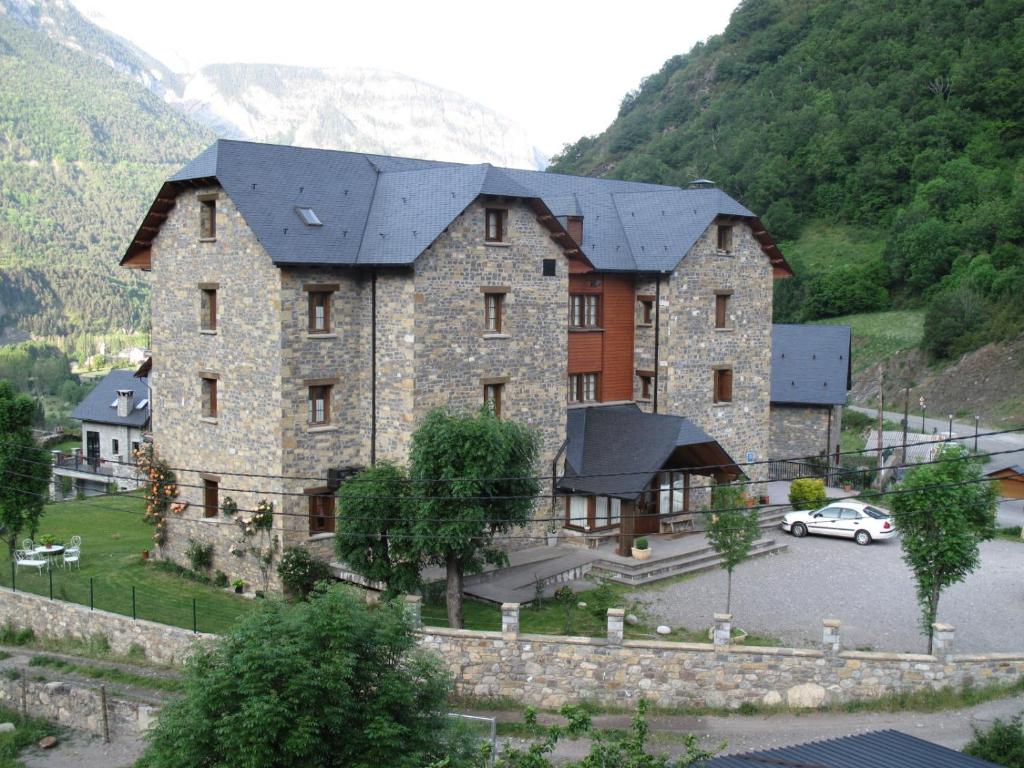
12 0 547 168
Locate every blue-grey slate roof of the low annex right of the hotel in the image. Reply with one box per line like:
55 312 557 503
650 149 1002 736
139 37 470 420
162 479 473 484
771 324 852 406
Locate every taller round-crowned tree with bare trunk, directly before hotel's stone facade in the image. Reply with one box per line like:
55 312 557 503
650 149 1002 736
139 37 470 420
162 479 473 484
410 408 539 628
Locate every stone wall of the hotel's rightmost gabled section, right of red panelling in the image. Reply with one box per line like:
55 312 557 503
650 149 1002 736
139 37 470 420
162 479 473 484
637 221 772 494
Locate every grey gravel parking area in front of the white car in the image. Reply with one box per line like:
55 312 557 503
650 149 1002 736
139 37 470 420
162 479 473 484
636 530 1024 653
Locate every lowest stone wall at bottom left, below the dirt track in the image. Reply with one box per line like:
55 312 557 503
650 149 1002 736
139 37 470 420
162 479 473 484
0 677 160 740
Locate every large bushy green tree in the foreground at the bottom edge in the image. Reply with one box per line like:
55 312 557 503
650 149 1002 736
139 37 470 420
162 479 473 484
139 587 468 768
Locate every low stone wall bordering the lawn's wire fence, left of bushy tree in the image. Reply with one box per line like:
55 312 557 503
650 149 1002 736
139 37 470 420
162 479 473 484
0 588 216 664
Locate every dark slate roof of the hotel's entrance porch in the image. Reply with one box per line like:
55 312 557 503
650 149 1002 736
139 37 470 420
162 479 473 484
558 404 741 500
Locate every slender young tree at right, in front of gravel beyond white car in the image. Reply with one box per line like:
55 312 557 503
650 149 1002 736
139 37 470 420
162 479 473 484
892 444 996 653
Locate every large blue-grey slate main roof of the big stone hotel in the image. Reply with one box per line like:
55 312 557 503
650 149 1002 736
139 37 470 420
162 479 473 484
144 139 787 272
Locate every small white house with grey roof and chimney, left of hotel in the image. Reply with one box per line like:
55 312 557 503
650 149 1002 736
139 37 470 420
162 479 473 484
53 371 151 498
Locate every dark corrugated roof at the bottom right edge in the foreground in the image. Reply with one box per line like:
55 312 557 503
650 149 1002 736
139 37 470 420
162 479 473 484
701 730 995 768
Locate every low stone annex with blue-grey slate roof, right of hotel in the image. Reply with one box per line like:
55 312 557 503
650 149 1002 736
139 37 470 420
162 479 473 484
769 324 852 459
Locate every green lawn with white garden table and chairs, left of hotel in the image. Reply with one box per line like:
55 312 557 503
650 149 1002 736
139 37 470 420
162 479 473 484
0 494 256 632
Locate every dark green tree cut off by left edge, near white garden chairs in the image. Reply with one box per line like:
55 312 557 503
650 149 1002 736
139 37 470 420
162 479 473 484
0 381 50 559
